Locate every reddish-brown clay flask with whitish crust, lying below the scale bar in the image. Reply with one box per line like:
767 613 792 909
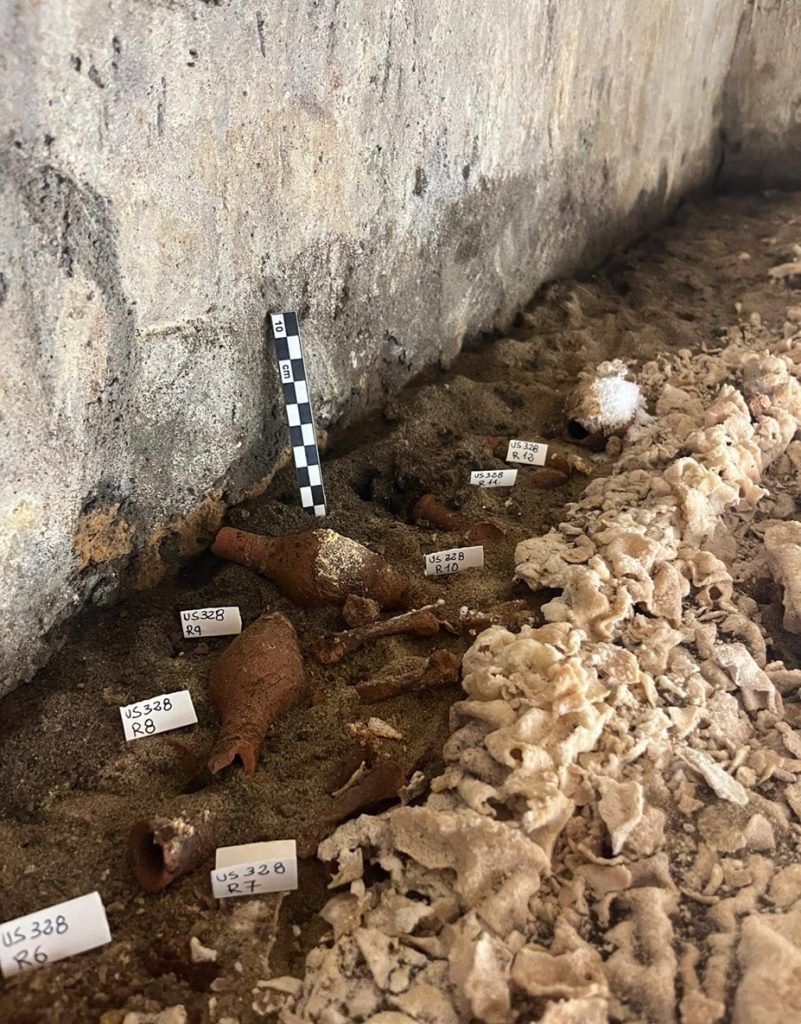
211 526 418 609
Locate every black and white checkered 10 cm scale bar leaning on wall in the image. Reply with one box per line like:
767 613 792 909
269 313 326 515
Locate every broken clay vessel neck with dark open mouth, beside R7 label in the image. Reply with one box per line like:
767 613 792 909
128 811 217 893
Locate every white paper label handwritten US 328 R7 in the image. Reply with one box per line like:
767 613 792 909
211 839 298 899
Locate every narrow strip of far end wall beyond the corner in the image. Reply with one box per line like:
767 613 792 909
722 0 801 187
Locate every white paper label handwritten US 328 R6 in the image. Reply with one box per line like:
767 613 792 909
0 892 112 978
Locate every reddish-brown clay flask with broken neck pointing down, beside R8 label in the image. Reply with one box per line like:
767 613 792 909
209 613 304 773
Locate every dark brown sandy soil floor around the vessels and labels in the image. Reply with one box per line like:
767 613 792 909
0 195 801 1024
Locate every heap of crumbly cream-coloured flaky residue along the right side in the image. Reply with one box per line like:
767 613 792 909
279 325 801 1024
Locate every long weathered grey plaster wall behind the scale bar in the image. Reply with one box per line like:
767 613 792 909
0 0 753 693
